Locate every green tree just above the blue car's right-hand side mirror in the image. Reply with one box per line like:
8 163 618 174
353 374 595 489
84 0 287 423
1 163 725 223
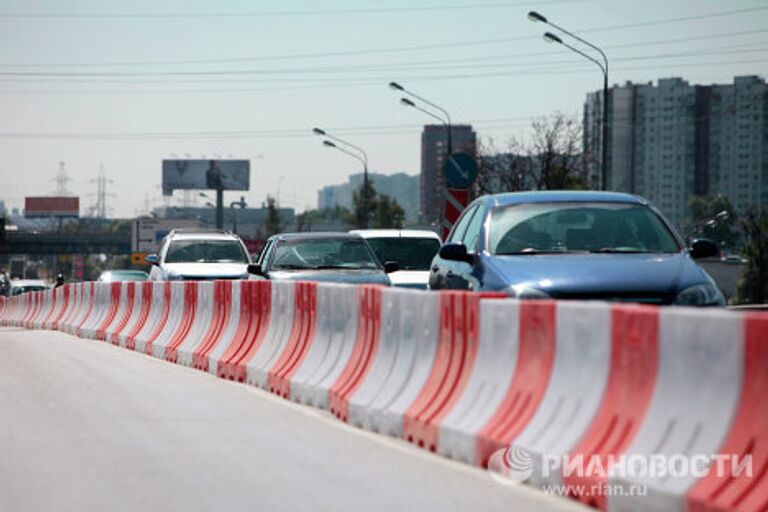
688 194 739 247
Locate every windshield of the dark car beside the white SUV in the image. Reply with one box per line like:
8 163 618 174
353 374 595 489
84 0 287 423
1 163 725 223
271 238 380 270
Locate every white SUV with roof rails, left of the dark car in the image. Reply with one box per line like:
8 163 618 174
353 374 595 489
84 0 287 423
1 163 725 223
146 229 251 281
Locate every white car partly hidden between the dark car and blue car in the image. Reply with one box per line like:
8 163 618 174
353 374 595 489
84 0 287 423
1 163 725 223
351 229 442 289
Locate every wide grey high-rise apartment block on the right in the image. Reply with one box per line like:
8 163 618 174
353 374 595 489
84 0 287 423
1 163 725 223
584 76 768 227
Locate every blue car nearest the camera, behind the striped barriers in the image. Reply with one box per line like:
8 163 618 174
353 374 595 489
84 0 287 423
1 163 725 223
429 191 725 306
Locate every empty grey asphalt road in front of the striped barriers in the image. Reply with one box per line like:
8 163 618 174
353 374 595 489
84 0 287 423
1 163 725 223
0 328 583 512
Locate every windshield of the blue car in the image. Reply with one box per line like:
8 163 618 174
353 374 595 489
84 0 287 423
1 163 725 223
488 202 681 254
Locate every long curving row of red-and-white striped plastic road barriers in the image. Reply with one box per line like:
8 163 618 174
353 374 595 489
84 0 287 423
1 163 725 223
0 281 768 511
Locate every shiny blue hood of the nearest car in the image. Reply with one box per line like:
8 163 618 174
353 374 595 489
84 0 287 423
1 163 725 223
486 253 709 296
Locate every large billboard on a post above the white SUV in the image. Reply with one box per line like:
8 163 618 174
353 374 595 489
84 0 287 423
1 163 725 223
163 160 251 196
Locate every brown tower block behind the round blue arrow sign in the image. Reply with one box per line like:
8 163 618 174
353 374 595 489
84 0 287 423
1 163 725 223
421 124 477 222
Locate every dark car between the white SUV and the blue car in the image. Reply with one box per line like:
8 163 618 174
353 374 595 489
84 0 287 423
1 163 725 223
248 233 399 286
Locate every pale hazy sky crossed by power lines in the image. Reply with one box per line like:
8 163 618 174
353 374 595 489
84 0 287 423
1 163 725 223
0 0 768 217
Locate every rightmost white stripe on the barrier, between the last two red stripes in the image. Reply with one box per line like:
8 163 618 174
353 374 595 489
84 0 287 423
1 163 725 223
608 308 744 511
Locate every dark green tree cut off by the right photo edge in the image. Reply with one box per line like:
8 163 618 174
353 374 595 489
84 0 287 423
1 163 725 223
736 210 768 304
